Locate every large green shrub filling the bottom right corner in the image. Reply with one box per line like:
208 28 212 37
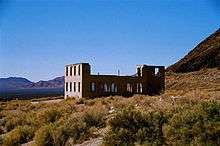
164 101 220 145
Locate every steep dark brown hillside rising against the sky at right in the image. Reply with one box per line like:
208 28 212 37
167 29 220 73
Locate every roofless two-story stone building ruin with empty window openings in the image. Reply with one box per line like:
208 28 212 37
65 63 165 99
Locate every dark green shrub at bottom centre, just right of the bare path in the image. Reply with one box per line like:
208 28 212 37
104 108 166 145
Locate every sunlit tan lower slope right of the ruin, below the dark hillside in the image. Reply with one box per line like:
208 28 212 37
166 68 220 94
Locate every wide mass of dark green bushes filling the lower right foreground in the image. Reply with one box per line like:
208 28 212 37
104 101 220 146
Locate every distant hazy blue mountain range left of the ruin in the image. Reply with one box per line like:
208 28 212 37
0 76 64 91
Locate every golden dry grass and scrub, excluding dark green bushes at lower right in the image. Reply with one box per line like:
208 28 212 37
0 69 220 145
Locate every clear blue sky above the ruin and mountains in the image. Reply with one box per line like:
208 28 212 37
0 0 220 81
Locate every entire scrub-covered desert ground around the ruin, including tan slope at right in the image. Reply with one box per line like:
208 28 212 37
0 69 220 146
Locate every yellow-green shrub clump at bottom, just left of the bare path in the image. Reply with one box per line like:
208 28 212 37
34 116 90 146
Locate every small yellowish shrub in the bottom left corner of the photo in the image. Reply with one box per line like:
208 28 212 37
3 125 34 146
